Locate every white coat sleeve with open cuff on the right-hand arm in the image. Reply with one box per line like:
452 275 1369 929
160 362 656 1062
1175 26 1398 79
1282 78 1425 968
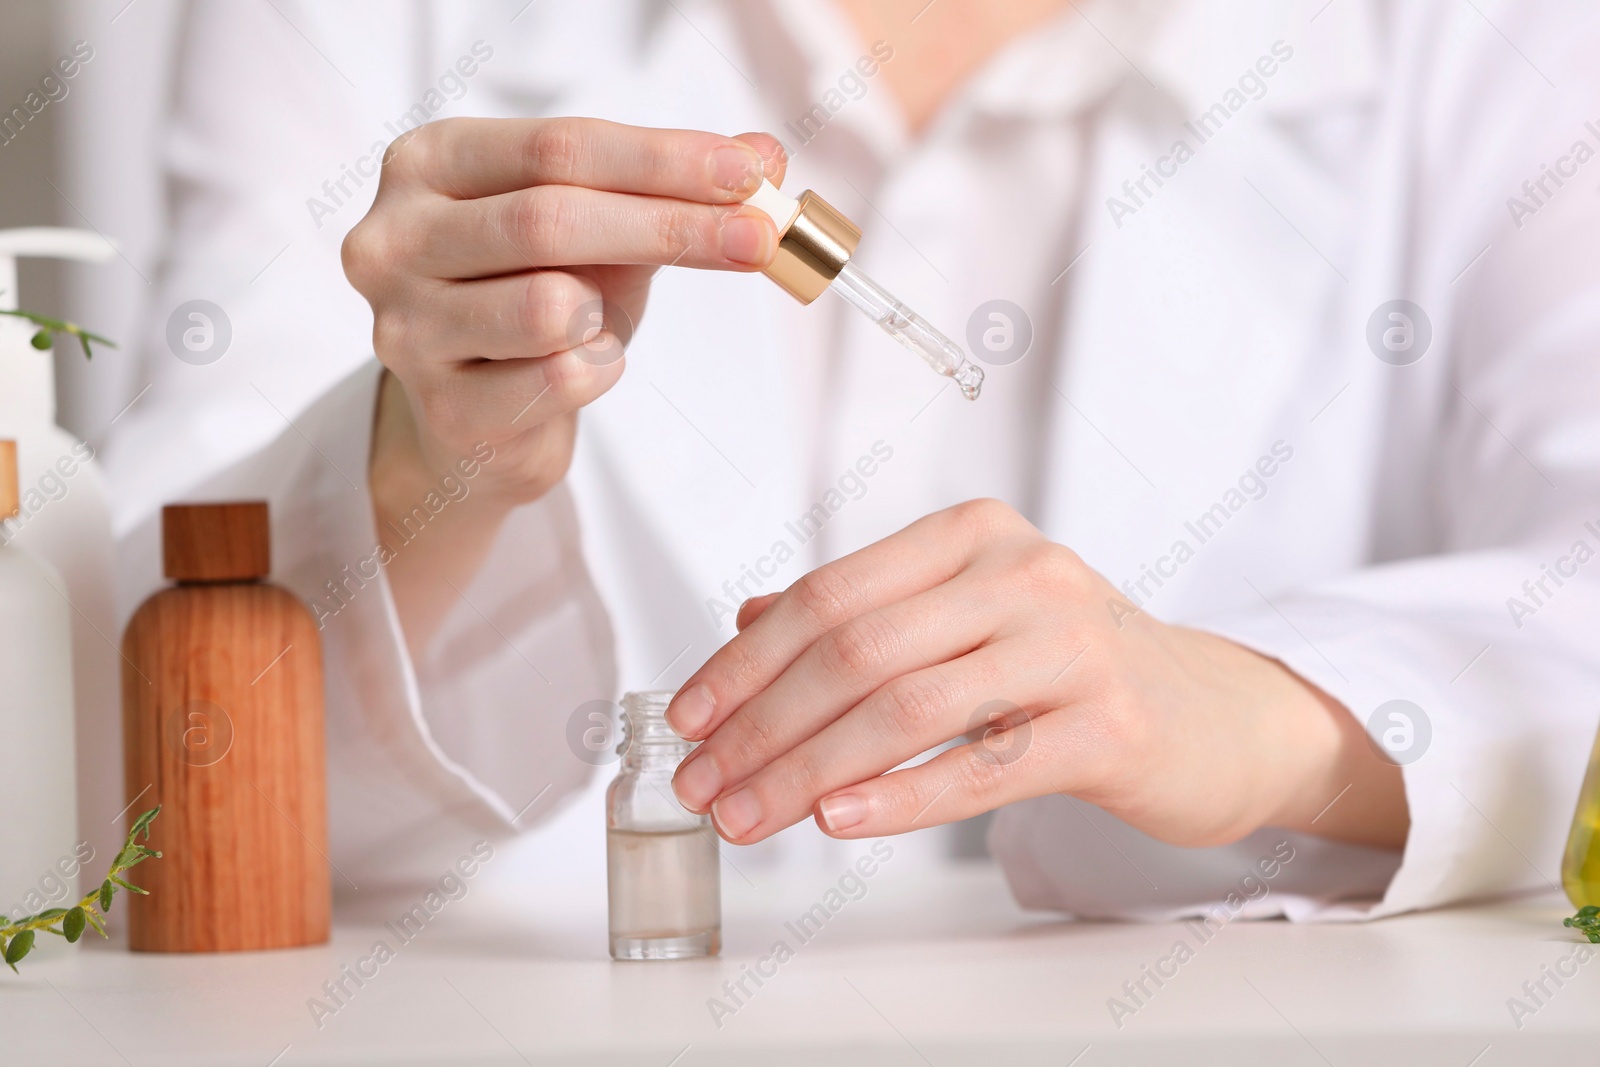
990 4 1600 920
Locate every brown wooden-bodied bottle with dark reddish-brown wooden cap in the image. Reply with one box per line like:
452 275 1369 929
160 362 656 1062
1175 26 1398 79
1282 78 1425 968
122 502 331 952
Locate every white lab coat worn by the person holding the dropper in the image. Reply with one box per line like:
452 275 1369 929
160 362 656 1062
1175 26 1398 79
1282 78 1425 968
84 0 1600 918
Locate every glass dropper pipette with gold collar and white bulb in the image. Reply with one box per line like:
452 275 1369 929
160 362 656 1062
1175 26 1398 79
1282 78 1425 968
746 181 984 400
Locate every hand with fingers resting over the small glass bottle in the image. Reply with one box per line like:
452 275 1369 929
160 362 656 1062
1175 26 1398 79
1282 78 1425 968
667 501 1408 846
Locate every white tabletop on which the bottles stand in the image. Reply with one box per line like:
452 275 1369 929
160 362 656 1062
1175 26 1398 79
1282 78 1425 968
0 844 1600 1067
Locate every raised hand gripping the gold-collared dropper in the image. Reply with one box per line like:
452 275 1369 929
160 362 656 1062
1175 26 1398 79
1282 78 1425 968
344 118 784 651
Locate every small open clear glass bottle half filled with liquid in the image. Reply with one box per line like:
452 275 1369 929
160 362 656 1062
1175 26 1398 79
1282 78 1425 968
605 693 722 960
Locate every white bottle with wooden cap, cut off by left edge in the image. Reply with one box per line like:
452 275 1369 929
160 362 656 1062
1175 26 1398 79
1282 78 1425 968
0 440 83 941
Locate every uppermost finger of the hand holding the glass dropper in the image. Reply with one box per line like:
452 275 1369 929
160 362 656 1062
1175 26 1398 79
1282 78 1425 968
384 118 784 203
